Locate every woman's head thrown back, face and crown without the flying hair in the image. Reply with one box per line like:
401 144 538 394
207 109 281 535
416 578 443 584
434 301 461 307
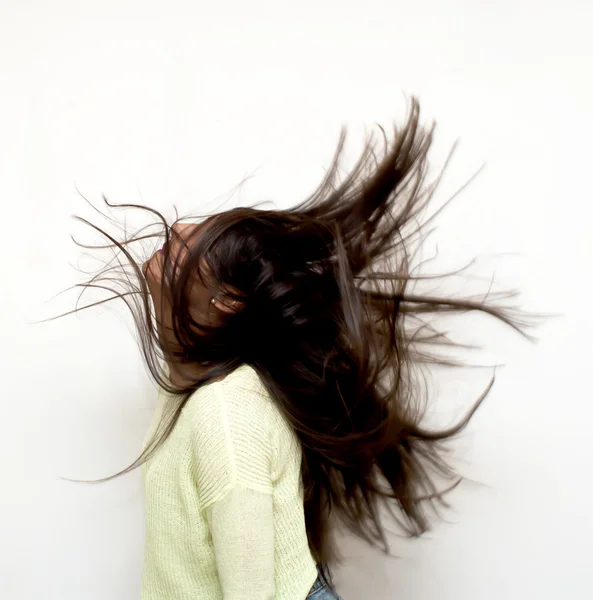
143 208 360 392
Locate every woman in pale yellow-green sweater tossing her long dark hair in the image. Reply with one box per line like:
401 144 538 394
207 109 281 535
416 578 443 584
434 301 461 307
65 100 519 600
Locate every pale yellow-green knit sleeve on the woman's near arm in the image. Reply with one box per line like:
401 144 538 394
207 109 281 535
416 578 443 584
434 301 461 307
194 382 274 600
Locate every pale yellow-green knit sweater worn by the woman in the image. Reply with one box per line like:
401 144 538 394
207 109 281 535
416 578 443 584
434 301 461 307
142 366 317 600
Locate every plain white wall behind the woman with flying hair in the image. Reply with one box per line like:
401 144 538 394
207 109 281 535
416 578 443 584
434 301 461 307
0 0 593 600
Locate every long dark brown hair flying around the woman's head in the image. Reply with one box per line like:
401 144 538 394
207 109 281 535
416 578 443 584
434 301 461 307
61 99 525 576
